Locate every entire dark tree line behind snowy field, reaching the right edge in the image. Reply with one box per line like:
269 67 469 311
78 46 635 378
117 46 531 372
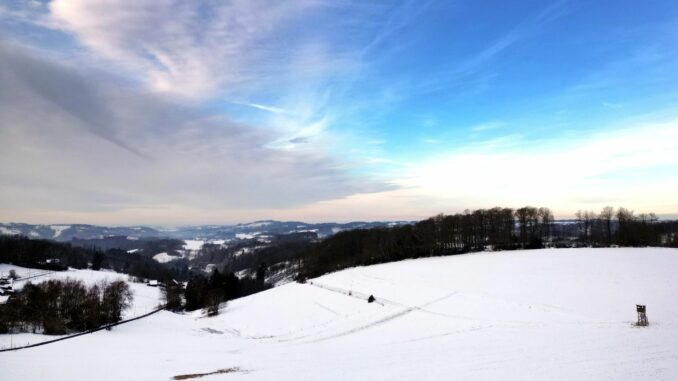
298 206 678 279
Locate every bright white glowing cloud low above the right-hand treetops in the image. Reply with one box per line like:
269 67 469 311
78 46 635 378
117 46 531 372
267 121 678 220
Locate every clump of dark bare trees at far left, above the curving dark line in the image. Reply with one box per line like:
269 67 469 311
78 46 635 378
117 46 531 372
0 278 133 335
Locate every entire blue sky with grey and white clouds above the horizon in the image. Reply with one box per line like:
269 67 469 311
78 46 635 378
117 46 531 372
0 0 678 225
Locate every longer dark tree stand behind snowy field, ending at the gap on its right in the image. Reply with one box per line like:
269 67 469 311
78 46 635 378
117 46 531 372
300 206 554 278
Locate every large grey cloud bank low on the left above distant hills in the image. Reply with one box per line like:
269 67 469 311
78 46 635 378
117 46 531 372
0 40 389 223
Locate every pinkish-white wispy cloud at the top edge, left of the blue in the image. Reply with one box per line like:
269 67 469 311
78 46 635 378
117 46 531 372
45 0 338 98
